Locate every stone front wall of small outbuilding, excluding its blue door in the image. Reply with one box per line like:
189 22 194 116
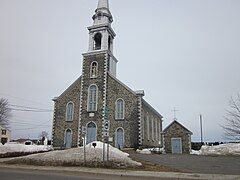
163 123 191 153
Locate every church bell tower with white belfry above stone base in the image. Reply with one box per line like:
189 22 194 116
78 0 118 145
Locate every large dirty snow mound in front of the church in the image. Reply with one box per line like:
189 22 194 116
7 142 142 168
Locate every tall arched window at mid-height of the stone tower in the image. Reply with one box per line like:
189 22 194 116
88 84 98 111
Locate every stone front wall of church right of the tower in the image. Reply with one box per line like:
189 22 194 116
107 75 139 148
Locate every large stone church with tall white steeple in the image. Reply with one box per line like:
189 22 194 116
52 0 162 149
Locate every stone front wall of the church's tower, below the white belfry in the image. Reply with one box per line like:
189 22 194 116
80 52 107 145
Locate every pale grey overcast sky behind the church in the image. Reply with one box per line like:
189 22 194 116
0 0 240 141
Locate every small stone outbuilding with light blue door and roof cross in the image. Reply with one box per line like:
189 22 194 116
163 120 193 154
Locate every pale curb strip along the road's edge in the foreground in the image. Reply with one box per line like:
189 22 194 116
0 163 240 180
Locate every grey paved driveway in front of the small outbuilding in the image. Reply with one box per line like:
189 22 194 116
130 153 240 175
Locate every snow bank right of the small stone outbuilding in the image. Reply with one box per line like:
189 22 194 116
192 143 240 155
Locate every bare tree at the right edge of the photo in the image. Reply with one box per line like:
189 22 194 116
222 94 240 140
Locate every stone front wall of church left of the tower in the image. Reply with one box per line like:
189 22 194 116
52 78 81 147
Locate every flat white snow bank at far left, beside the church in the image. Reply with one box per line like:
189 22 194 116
0 143 52 154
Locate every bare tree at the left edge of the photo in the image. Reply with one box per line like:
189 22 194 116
0 98 11 128
